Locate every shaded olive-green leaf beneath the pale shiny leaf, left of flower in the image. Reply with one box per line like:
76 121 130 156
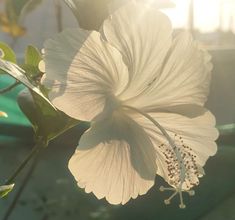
18 90 79 142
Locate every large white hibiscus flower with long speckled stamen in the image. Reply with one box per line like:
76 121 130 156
42 1 218 207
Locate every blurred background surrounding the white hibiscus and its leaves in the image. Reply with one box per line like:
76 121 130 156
0 0 235 220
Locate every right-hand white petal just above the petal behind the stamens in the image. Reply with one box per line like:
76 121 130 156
127 32 212 111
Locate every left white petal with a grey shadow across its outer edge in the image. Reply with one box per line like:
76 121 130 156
42 29 128 121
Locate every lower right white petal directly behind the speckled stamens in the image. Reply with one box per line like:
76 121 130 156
130 111 218 189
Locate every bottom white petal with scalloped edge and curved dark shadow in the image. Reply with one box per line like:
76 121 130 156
69 113 156 204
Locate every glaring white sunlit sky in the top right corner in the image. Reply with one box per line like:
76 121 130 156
161 0 235 33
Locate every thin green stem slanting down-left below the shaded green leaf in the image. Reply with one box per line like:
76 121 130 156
4 142 44 185
